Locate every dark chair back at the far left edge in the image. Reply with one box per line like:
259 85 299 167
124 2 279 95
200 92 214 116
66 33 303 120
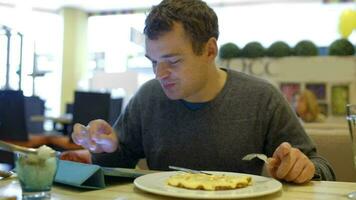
0 90 28 141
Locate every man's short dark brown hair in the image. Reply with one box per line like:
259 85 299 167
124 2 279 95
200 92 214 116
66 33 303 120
144 0 219 55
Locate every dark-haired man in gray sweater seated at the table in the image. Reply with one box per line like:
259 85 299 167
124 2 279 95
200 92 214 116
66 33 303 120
72 0 335 183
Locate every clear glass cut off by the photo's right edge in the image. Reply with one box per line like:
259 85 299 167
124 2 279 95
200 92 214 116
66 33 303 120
346 104 356 199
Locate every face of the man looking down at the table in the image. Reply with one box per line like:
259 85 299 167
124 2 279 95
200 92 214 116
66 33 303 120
146 23 209 102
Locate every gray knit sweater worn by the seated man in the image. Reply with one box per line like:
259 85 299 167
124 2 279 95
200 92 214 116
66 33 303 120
93 70 335 180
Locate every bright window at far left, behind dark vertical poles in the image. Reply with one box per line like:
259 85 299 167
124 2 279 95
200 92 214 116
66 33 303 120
0 6 63 115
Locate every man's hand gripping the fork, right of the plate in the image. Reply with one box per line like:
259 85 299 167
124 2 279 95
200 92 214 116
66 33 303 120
267 142 315 184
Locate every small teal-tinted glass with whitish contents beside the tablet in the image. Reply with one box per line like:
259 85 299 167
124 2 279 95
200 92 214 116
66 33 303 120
15 153 58 200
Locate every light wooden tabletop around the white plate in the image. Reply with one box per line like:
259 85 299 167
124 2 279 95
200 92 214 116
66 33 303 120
0 178 356 200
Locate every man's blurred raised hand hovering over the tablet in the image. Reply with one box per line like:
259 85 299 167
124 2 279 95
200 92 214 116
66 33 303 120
72 119 118 153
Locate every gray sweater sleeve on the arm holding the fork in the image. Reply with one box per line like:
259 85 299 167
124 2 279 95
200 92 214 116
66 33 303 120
264 86 335 181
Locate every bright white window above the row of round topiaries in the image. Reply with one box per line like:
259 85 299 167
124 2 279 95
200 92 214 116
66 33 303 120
214 2 356 47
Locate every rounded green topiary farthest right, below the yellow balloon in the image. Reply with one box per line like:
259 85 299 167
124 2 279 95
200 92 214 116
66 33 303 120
329 39 355 56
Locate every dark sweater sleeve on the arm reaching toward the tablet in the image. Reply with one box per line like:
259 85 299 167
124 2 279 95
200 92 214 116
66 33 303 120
92 94 144 168
